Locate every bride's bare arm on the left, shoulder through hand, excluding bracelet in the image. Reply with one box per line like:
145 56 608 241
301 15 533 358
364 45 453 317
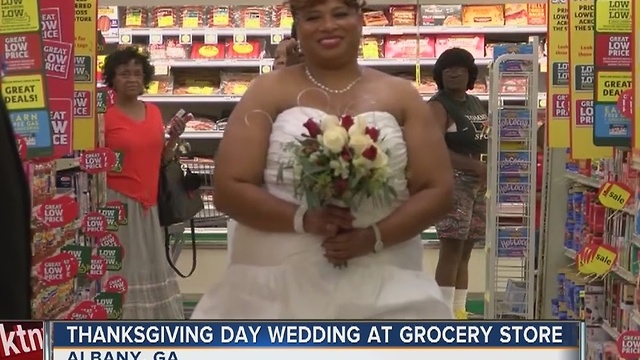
213 72 351 236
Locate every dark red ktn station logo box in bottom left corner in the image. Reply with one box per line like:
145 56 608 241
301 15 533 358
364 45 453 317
0 321 45 360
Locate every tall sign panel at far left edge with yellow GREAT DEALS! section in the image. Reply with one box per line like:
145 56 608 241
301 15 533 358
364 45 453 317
0 1 53 158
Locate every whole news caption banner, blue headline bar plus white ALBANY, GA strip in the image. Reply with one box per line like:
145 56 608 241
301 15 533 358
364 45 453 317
52 321 586 360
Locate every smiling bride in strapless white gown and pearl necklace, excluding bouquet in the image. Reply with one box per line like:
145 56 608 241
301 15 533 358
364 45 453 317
192 0 453 319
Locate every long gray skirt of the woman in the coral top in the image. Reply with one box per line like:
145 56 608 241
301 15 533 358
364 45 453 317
107 189 184 320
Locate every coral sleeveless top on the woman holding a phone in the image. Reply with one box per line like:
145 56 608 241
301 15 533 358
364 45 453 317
105 104 165 208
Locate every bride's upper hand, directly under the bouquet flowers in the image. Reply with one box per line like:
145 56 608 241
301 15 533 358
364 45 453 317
304 206 354 237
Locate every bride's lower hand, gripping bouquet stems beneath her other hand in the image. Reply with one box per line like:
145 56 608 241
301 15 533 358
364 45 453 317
322 227 376 264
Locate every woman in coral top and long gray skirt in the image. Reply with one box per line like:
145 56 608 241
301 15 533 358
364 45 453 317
103 48 184 320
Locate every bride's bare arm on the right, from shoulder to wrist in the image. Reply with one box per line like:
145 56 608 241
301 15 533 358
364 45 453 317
378 82 453 246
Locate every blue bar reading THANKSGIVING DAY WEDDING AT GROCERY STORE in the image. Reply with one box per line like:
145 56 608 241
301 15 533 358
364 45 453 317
48 321 581 350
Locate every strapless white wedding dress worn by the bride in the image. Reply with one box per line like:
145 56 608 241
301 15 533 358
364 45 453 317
192 106 453 319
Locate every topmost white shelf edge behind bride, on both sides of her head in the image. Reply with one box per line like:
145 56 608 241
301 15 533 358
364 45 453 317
112 26 547 38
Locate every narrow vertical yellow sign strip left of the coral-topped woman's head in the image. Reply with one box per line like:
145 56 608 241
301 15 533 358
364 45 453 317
73 0 98 150
